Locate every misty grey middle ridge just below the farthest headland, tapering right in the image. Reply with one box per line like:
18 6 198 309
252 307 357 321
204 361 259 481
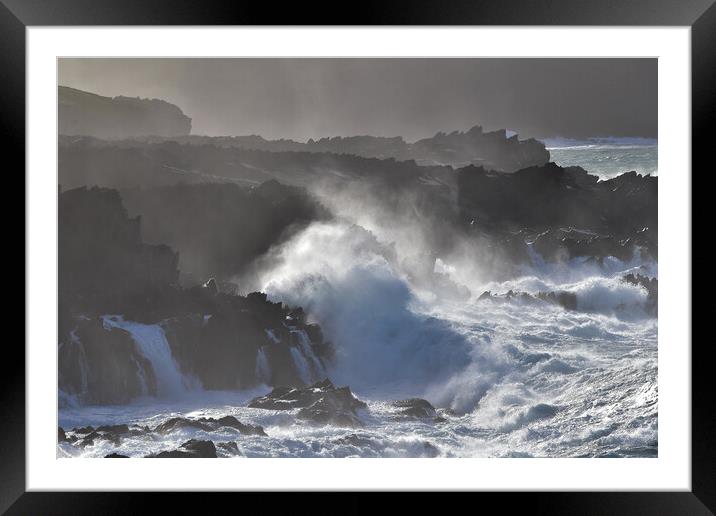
58 137 452 189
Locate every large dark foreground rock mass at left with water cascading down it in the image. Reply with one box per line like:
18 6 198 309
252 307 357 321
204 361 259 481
59 183 332 404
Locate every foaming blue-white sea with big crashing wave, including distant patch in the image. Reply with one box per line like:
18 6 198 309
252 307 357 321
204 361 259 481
57 139 658 458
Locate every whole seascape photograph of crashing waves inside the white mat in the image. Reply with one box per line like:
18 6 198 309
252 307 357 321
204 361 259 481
57 58 670 458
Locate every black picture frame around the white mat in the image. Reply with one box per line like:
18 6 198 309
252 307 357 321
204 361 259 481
0 0 716 514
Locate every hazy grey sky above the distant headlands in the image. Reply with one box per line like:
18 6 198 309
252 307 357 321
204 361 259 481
59 58 657 140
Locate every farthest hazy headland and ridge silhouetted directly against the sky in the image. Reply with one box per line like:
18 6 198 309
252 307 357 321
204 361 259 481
59 86 549 172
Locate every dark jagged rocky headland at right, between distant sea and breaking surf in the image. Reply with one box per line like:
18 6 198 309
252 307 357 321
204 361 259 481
457 163 658 261
